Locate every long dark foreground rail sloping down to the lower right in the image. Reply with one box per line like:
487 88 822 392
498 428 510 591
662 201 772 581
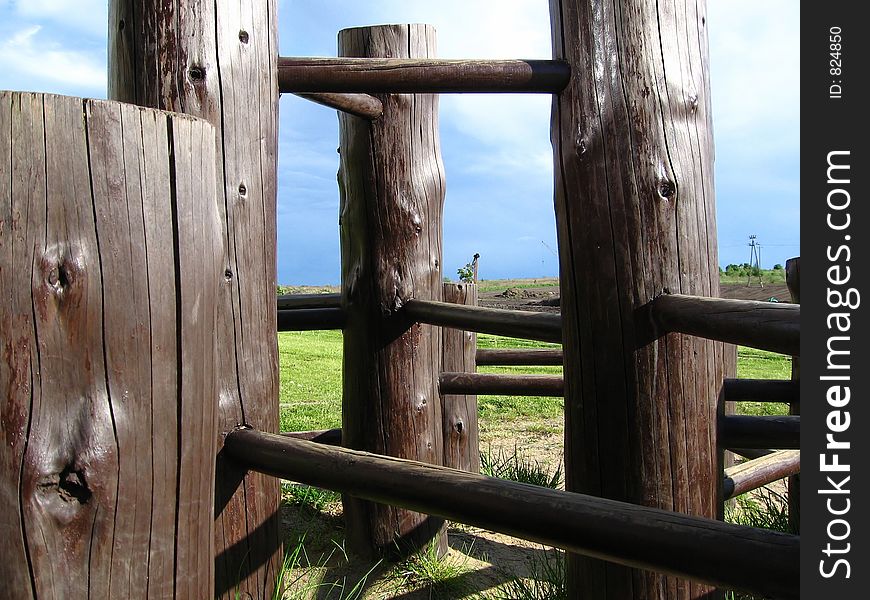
224 429 800 598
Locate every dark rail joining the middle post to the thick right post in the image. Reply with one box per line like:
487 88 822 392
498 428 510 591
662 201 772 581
405 300 562 343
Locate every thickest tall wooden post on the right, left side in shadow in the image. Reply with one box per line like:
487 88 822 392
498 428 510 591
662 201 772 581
551 0 723 600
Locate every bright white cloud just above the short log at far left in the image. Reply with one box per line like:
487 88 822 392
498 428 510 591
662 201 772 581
0 25 106 92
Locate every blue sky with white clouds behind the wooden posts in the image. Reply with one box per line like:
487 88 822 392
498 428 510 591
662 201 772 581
0 0 800 284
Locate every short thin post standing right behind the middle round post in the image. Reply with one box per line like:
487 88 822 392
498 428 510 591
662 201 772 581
441 283 480 473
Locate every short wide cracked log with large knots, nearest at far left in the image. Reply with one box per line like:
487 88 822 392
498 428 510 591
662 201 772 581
0 92 224 598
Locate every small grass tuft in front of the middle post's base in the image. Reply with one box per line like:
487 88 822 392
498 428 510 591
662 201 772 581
394 542 472 600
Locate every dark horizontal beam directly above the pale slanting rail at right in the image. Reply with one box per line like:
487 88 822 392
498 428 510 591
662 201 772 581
719 415 801 450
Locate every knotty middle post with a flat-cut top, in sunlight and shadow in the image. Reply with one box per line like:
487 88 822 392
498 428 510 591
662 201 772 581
338 25 444 556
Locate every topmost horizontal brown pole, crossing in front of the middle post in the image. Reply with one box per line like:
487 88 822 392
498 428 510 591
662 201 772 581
278 57 571 94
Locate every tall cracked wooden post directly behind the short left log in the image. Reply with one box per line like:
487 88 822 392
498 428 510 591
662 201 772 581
109 0 281 598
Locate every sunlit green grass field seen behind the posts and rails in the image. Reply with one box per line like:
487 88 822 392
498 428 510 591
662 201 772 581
278 331 791 431
